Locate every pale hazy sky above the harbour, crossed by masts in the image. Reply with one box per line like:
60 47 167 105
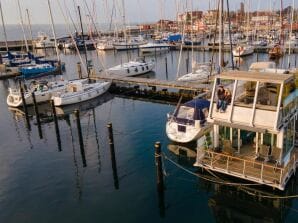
0 0 298 24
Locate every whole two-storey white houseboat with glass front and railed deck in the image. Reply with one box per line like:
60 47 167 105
195 71 298 190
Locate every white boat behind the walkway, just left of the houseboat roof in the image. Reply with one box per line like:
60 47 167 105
178 63 211 81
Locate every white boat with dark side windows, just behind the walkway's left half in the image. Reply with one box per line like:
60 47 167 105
107 58 155 76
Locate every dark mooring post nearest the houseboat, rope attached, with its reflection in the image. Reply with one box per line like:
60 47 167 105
154 142 165 217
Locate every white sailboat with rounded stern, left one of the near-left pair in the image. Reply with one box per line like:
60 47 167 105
6 81 67 107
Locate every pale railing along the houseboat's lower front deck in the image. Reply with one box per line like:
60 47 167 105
203 150 296 185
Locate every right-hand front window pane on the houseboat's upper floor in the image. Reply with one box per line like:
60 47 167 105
256 83 280 109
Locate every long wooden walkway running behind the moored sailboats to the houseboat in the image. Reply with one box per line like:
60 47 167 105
91 75 211 91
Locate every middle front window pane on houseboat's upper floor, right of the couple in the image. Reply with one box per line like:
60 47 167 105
235 81 257 108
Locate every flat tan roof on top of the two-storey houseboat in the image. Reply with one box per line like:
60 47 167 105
217 71 294 84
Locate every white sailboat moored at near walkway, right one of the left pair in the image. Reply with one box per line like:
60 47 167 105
52 79 111 106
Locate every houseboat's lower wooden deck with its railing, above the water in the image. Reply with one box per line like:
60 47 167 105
195 146 298 190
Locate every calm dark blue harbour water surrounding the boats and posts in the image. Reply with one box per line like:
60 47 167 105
0 37 298 223
